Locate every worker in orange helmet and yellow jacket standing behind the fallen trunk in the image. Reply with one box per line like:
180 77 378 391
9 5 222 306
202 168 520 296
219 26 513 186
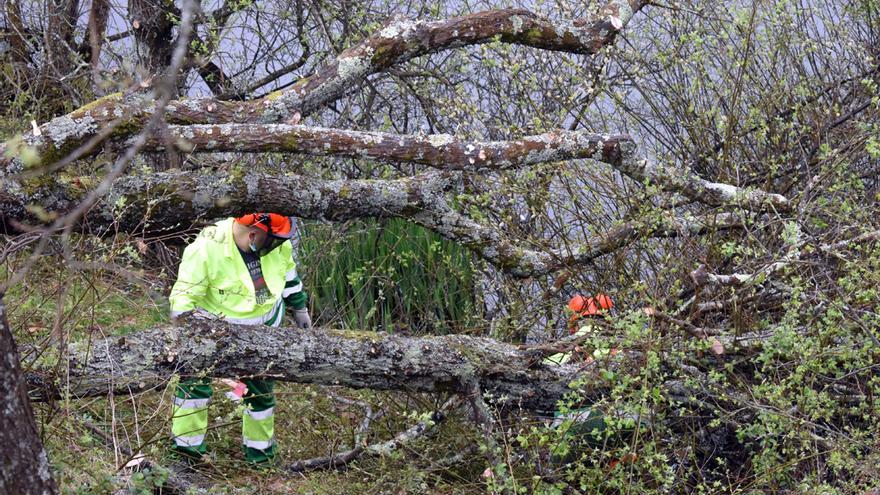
169 213 312 463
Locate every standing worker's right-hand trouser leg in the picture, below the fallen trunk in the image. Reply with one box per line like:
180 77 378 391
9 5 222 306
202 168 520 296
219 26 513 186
241 380 275 462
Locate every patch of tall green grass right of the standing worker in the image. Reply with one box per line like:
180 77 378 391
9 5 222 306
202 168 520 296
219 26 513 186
298 219 480 334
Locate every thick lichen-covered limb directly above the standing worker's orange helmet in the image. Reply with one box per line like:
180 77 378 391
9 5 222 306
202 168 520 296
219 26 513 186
0 169 452 233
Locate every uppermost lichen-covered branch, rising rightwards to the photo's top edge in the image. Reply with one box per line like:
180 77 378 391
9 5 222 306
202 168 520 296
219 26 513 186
0 0 647 174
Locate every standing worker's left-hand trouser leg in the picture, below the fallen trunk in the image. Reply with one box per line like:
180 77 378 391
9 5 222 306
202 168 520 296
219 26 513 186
171 379 212 456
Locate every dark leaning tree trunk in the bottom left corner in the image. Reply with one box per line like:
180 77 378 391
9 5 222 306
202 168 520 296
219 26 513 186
0 296 58 495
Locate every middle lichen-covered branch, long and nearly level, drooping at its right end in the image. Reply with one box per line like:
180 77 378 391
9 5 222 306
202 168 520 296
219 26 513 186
129 124 791 211
